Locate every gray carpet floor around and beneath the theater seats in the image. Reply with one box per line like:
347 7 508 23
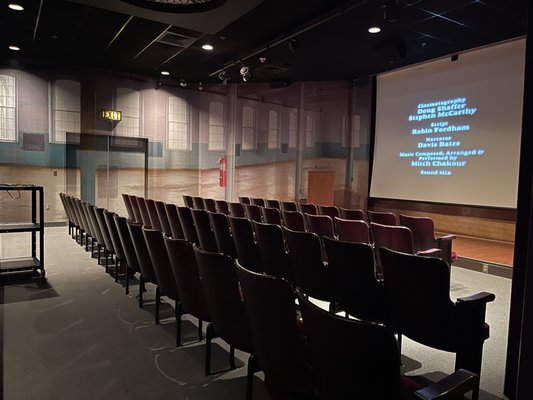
0 227 511 400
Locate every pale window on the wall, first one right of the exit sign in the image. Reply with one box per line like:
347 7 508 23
168 97 189 150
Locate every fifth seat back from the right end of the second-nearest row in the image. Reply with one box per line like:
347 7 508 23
228 216 263 272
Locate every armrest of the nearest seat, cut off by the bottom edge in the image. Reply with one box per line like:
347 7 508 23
413 369 479 400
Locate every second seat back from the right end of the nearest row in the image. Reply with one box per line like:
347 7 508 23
237 262 313 393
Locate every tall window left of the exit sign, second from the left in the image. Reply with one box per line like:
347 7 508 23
52 80 81 143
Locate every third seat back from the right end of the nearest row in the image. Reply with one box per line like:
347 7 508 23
193 245 253 353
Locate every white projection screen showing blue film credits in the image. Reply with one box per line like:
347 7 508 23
370 39 525 208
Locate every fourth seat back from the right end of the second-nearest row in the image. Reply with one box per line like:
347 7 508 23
253 222 294 282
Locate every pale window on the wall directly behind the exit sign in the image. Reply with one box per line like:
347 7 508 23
115 88 141 137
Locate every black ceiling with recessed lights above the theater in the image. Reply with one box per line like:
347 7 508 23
0 0 527 86
